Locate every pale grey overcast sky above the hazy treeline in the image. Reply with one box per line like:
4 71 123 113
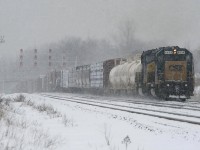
0 0 200 55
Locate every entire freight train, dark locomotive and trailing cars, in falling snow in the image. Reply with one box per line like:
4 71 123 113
17 46 194 100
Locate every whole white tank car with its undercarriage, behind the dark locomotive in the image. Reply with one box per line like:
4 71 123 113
109 55 142 94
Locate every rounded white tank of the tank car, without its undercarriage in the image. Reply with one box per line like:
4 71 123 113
109 59 142 89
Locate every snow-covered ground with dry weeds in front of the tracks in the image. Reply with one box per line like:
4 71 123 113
0 94 200 150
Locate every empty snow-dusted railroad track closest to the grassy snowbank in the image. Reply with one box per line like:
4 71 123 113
41 94 200 125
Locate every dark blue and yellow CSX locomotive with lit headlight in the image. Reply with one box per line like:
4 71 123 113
142 46 194 99
